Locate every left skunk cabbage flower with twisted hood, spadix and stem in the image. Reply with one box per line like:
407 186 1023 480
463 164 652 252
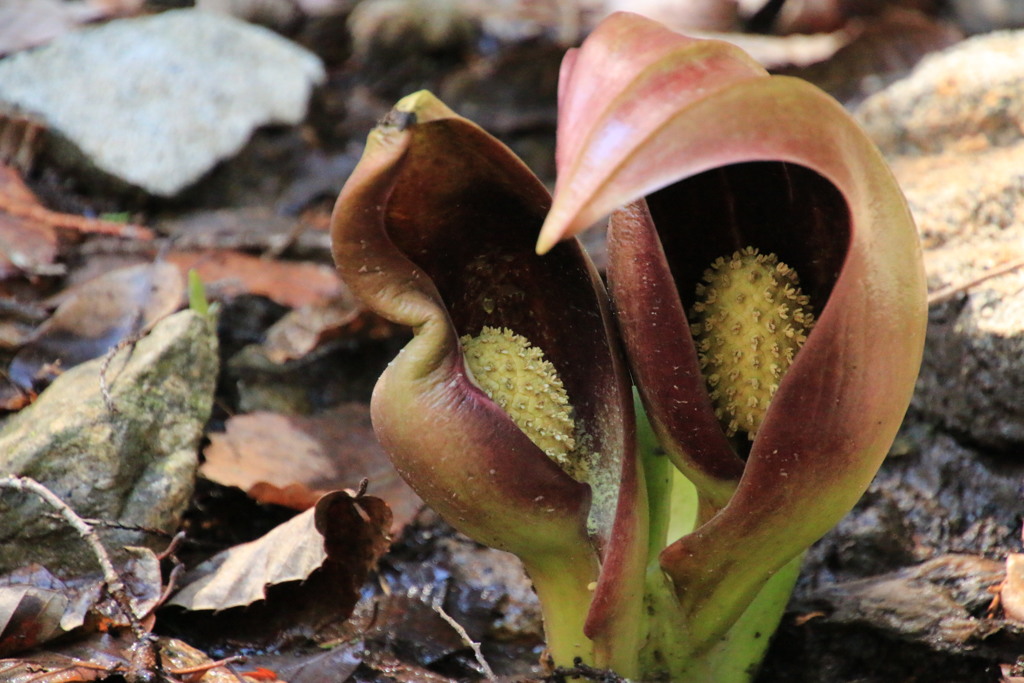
333 92 647 673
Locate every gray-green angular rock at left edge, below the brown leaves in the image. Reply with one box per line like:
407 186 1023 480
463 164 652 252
0 311 218 575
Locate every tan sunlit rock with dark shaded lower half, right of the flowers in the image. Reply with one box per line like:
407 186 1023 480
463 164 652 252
893 152 1024 451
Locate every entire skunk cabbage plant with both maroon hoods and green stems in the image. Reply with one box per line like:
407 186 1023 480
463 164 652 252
332 13 926 682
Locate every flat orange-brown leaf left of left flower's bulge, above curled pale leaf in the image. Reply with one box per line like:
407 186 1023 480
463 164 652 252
200 403 423 531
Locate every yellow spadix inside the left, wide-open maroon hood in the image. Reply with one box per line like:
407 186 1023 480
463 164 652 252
459 327 585 480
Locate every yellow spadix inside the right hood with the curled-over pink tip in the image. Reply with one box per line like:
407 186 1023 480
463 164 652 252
690 247 814 439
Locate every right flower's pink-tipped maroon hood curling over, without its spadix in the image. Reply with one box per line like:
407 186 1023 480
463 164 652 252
539 13 927 642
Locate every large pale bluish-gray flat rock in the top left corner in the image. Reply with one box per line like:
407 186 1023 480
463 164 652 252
0 9 325 197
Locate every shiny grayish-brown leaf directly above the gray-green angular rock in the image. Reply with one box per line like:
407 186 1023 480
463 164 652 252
8 263 184 389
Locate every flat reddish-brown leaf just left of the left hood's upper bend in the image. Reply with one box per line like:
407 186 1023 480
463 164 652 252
167 249 344 308
